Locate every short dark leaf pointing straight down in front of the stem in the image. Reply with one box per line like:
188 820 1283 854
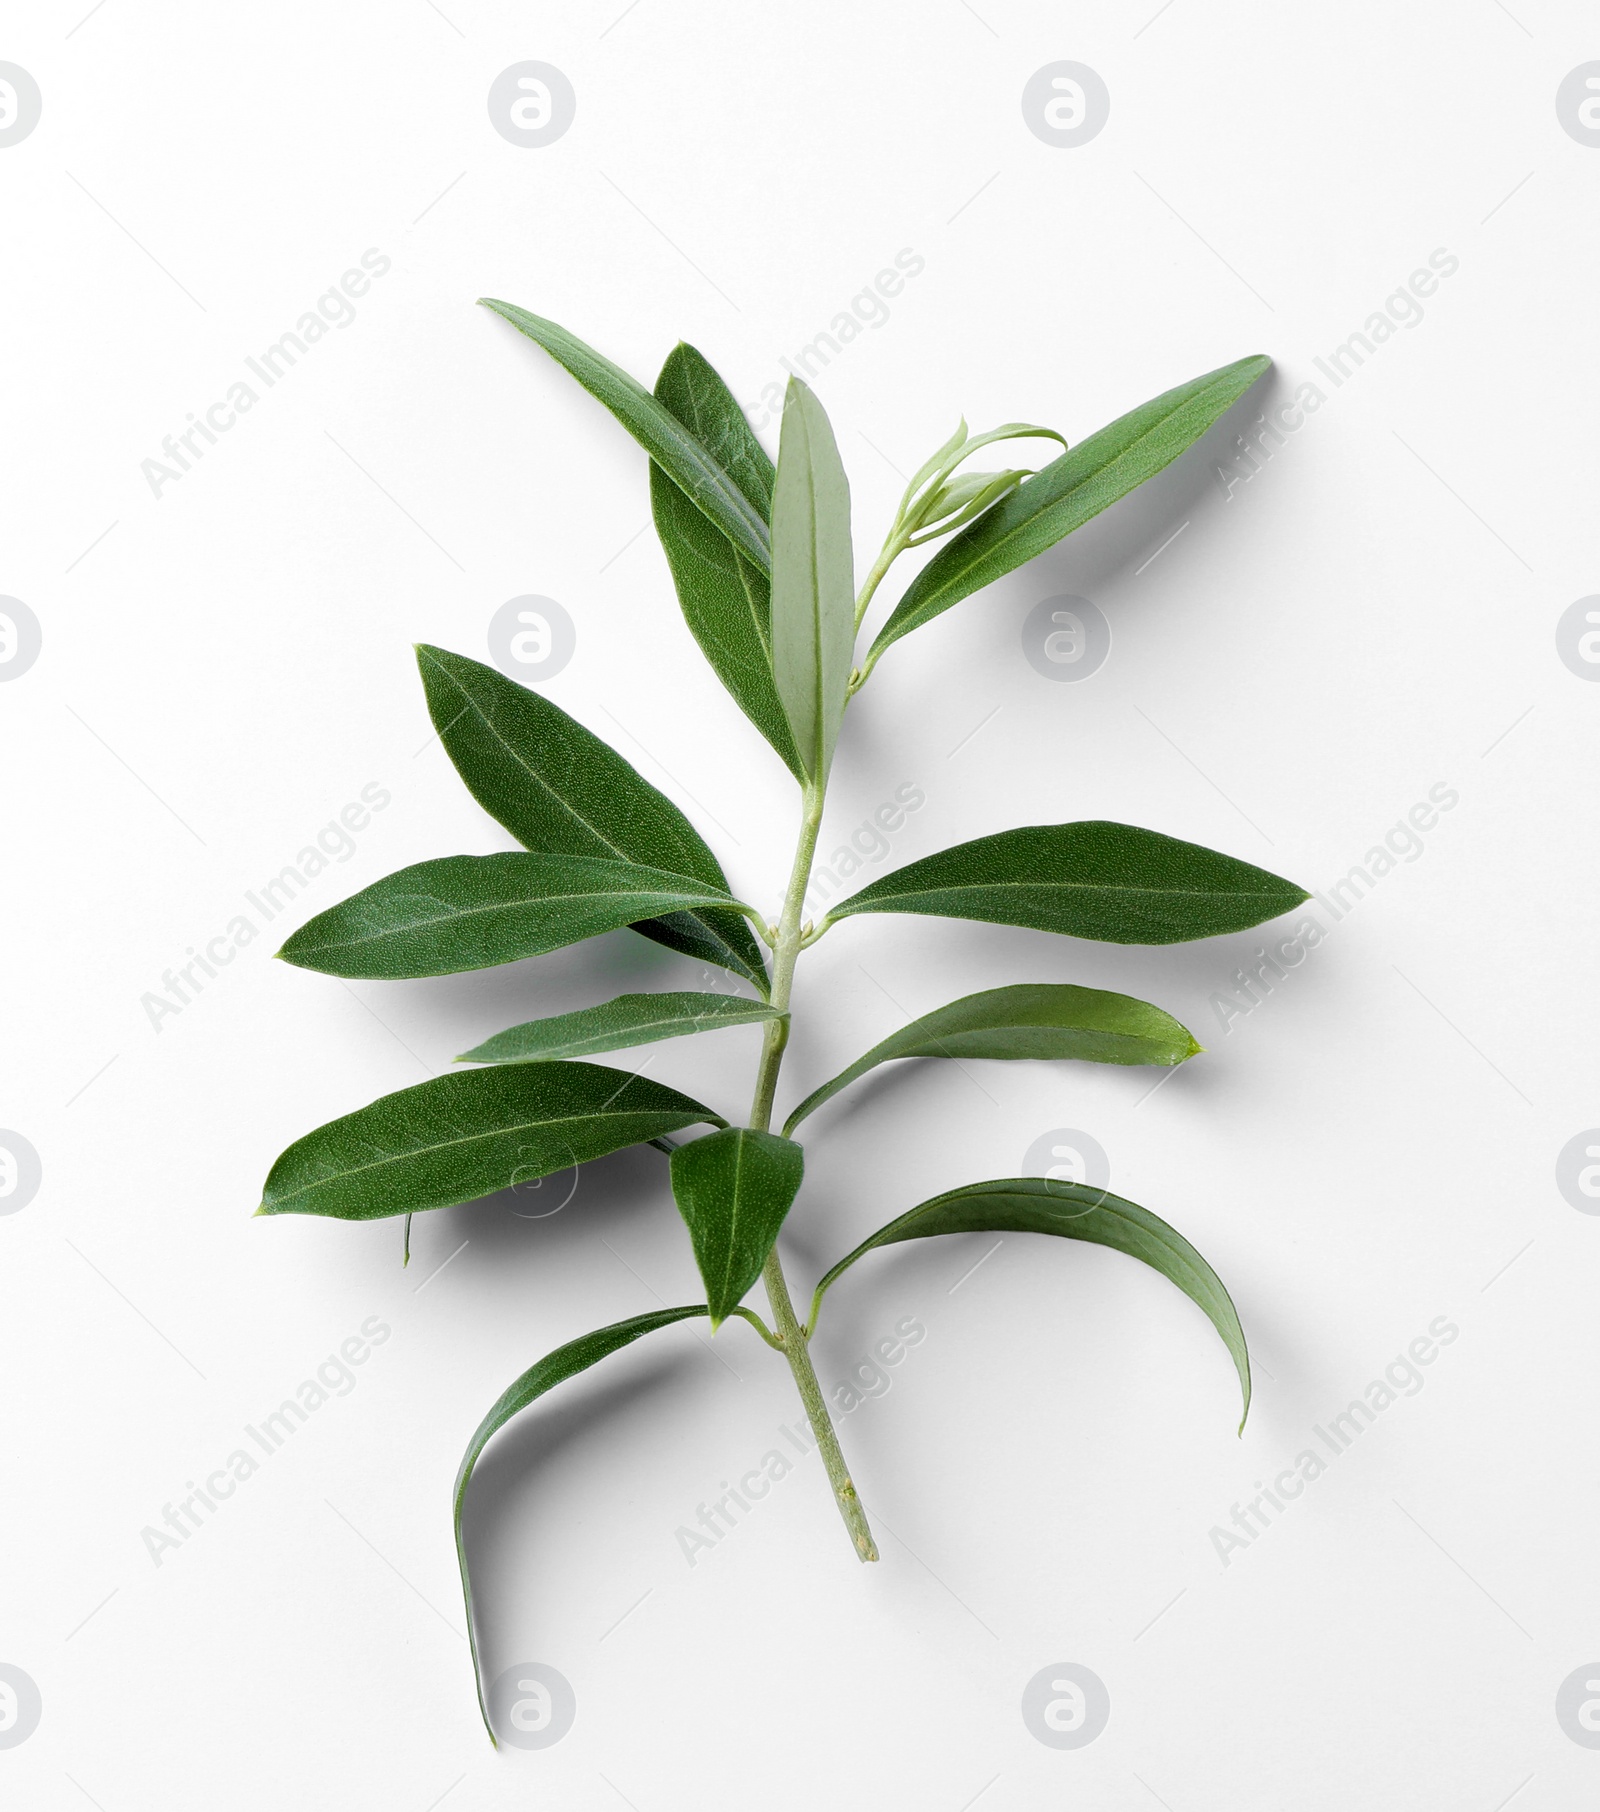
672 1127 805 1328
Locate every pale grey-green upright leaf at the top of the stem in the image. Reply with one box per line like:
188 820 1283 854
772 377 855 785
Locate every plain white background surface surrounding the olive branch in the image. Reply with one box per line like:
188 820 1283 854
0 0 1600 1812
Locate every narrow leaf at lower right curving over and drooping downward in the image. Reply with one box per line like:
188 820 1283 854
810 1176 1250 1428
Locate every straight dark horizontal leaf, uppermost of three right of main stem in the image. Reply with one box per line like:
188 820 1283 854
828 819 1310 944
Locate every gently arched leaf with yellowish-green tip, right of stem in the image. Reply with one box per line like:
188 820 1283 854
783 982 1200 1133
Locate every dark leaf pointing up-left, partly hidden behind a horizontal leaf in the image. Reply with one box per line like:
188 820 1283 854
417 643 768 995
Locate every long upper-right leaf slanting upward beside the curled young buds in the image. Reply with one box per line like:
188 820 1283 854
872 353 1272 660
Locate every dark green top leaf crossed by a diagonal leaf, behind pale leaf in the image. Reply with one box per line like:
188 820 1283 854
651 346 805 779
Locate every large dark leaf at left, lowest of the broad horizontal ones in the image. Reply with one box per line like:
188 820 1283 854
257 1064 725 1221
